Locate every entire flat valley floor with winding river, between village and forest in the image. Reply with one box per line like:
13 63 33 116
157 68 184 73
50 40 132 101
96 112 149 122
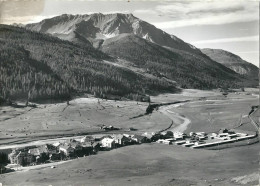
0 90 257 147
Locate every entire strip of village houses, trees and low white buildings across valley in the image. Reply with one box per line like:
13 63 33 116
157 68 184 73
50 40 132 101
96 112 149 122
0 129 258 168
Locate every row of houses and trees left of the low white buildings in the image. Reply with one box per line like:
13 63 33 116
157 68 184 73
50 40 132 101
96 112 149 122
8 131 173 166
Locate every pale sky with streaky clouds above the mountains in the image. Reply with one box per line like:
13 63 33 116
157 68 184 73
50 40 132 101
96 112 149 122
0 0 259 66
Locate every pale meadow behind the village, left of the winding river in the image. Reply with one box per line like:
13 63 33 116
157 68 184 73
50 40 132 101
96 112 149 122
0 98 171 144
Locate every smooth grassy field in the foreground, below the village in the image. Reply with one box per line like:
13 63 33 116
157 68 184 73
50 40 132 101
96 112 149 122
0 143 259 185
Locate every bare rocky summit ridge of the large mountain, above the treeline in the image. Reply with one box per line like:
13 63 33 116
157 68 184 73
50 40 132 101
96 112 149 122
26 13 200 53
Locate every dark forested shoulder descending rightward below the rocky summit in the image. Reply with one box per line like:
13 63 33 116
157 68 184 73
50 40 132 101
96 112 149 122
100 34 248 89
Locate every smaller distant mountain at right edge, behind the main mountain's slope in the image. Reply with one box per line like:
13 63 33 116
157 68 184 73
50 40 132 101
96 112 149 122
201 48 259 79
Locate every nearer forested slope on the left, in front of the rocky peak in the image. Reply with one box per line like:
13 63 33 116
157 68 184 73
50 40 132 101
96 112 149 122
0 25 177 100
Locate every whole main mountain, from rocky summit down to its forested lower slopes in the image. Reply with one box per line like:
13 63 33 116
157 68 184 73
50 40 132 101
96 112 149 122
0 14 257 100
